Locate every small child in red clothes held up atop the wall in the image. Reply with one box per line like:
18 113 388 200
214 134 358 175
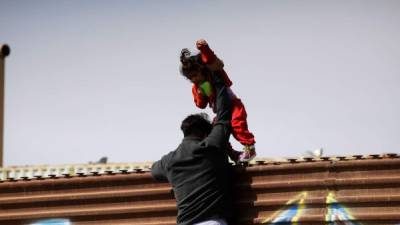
180 39 256 162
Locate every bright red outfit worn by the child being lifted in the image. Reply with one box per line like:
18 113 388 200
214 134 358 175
192 45 255 145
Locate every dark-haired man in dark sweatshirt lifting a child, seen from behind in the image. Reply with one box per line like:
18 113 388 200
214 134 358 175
151 71 232 225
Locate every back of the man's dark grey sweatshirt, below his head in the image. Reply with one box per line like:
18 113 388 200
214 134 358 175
155 137 231 224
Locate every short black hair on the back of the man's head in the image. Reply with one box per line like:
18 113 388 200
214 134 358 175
181 113 212 138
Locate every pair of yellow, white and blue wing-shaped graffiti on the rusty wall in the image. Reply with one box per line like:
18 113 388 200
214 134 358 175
263 192 361 225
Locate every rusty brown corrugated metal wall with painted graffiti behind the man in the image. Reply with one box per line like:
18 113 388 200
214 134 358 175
0 154 400 225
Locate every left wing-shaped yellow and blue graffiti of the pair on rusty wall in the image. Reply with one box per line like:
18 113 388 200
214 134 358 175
263 192 307 224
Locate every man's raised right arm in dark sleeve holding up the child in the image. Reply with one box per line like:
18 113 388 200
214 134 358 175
205 68 232 149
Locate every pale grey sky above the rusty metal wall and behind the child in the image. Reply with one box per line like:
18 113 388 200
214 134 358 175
0 0 400 166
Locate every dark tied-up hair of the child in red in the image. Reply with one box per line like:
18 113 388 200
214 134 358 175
179 48 210 80
